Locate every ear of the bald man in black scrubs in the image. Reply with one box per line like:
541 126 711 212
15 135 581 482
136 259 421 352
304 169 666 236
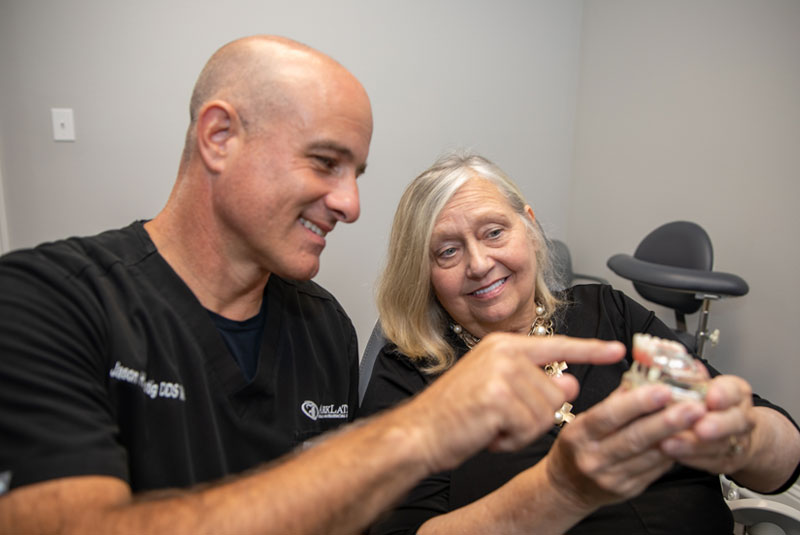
195 100 242 173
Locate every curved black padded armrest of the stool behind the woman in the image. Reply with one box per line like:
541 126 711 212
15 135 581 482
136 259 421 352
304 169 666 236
607 254 750 297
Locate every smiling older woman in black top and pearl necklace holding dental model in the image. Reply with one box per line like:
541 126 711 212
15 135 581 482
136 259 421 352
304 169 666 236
360 155 800 534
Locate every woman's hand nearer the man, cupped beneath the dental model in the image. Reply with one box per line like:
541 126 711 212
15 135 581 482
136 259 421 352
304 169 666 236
545 385 706 513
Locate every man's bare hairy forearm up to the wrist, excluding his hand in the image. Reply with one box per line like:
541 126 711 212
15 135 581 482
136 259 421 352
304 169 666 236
0 410 428 535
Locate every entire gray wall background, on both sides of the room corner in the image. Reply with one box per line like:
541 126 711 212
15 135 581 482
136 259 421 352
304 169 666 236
0 0 800 414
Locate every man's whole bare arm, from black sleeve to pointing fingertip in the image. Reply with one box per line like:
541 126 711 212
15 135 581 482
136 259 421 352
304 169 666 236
0 335 624 535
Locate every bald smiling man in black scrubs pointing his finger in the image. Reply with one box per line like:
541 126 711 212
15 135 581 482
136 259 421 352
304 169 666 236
0 36 623 534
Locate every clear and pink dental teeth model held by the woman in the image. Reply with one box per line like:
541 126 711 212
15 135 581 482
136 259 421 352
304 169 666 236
622 333 709 401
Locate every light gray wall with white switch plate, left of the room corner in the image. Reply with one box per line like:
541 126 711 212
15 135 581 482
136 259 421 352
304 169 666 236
0 0 582 364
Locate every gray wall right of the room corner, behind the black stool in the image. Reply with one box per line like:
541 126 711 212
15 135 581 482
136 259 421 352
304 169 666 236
568 0 800 415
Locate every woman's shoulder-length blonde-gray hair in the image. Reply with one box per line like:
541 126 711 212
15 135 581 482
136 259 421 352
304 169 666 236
377 153 560 374
